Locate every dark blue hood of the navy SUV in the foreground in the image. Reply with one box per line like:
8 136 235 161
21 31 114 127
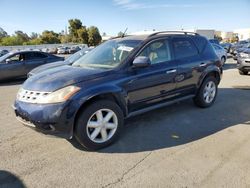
22 65 110 92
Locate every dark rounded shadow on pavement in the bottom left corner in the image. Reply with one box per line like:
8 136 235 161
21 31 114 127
0 170 26 188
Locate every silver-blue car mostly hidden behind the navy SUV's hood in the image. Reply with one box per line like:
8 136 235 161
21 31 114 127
28 49 91 77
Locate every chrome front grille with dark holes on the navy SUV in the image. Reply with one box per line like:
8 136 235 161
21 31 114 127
17 89 50 103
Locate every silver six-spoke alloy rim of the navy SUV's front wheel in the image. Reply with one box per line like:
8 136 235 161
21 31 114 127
86 109 118 143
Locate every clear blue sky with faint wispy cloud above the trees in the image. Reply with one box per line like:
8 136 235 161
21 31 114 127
0 0 250 35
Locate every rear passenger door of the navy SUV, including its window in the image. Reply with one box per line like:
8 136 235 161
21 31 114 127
173 36 207 96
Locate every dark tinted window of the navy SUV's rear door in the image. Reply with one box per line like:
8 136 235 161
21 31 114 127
173 38 198 59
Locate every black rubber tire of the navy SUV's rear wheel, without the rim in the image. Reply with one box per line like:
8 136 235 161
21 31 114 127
193 76 218 108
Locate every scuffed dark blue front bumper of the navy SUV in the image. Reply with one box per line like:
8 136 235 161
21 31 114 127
13 101 74 139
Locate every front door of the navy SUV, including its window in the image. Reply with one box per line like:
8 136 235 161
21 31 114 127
127 39 177 112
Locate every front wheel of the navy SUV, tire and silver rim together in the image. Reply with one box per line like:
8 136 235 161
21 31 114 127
75 100 124 150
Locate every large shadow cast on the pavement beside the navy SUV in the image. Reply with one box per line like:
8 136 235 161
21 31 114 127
71 88 250 153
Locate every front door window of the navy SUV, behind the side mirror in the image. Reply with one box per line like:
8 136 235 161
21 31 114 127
139 40 171 64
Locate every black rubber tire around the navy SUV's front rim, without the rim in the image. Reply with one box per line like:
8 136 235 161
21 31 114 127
74 100 124 150
